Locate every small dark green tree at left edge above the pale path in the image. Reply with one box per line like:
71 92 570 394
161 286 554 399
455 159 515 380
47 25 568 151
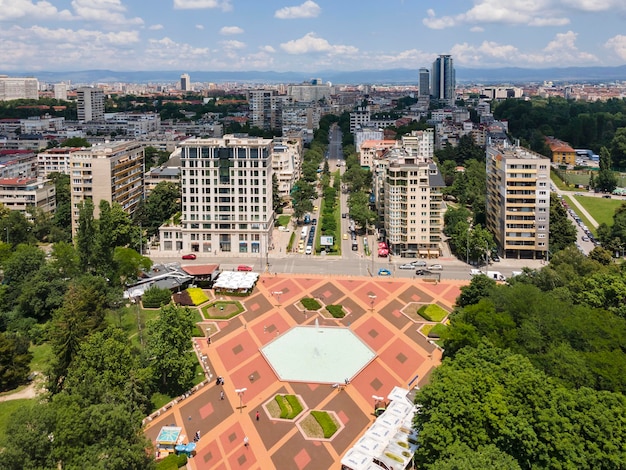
0 332 33 392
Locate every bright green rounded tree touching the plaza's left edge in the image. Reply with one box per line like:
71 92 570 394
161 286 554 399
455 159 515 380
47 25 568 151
146 305 196 395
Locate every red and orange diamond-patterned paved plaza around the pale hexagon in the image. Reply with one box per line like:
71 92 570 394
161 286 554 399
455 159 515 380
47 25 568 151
145 274 467 470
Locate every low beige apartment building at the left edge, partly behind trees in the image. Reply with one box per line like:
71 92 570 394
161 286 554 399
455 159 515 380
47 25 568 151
0 177 56 218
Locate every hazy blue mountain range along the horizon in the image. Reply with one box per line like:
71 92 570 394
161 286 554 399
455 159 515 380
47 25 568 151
0 65 626 84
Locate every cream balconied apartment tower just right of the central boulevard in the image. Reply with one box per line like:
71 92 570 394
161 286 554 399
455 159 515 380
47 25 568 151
382 149 445 258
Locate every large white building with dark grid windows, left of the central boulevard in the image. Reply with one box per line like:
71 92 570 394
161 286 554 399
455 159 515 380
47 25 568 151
159 134 274 261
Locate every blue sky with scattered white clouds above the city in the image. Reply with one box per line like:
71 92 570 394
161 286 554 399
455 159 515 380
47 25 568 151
0 0 626 72
